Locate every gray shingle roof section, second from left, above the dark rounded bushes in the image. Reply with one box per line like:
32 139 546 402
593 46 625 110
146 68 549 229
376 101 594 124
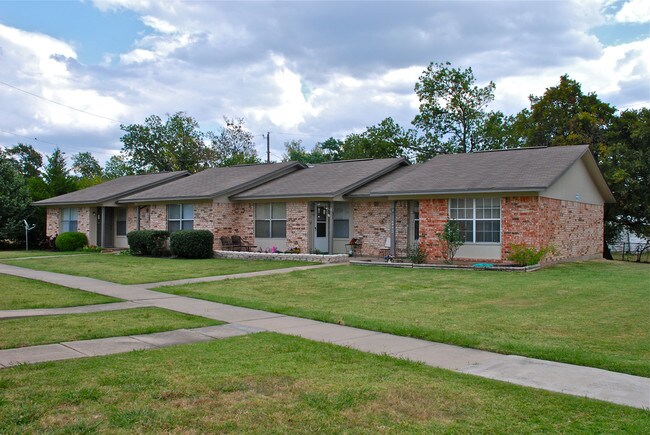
118 162 304 203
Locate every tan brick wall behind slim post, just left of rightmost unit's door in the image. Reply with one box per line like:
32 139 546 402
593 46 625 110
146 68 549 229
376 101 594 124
352 201 408 257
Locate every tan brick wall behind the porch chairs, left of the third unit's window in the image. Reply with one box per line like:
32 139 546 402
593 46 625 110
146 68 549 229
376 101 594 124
212 201 255 249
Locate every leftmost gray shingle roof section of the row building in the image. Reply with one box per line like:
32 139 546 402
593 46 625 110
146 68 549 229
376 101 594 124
34 171 189 205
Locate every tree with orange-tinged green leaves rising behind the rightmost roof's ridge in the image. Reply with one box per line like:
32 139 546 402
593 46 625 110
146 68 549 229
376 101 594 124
516 74 616 152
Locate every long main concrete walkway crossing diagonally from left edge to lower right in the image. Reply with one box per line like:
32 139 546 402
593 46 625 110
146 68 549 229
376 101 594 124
0 264 650 409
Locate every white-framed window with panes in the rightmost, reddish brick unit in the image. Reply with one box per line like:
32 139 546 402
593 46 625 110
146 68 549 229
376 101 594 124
449 198 501 243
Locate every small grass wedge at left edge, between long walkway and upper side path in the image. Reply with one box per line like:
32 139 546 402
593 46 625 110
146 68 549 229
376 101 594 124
0 274 120 310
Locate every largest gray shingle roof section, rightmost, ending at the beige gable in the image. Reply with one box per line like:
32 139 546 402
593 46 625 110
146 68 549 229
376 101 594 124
349 145 604 197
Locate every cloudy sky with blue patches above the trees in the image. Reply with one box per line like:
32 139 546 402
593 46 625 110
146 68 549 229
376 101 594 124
0 0 650 167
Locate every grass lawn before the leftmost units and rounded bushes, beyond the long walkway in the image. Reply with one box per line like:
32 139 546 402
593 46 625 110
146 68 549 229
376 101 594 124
2 254 314 284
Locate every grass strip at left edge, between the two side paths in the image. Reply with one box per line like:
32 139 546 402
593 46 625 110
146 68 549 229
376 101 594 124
0 308 221 350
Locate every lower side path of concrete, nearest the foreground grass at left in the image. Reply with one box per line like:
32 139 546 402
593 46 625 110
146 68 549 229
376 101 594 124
0 325 259 368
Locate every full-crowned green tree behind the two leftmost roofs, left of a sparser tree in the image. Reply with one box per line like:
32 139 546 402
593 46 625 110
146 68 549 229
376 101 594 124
120 112 214 173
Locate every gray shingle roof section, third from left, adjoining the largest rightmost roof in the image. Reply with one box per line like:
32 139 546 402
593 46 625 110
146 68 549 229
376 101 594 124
233 158 408 200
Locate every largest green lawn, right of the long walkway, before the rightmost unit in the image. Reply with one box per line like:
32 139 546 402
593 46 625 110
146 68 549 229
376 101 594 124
157 261 650 376
